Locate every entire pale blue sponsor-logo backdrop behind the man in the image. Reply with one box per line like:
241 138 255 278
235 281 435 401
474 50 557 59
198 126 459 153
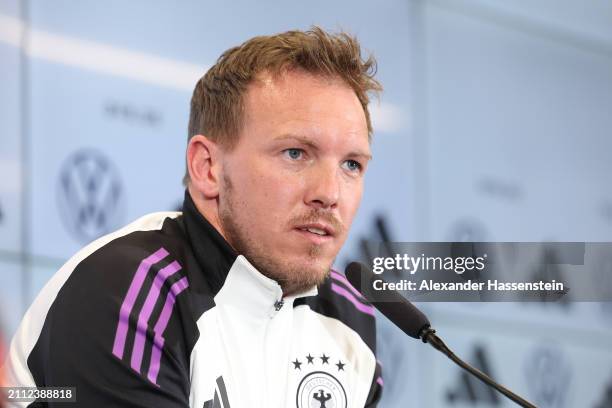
0 0 612 408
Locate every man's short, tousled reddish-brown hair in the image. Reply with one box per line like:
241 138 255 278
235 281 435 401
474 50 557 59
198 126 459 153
183 26 382 185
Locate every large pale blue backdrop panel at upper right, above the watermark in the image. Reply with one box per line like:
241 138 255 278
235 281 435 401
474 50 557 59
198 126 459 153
426 2 612 241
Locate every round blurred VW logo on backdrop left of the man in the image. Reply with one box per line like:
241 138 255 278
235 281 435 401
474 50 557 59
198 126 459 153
58 149 123 243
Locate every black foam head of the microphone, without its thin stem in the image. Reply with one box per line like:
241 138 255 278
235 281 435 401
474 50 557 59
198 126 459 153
345 262 431 339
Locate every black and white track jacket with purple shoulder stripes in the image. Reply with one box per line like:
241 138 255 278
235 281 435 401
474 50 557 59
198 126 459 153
6 194 382 408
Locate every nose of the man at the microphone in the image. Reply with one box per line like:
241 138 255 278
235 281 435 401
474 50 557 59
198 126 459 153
305 164 340 209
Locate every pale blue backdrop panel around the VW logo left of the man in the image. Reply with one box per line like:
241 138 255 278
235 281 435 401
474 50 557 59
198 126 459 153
30 61 188 258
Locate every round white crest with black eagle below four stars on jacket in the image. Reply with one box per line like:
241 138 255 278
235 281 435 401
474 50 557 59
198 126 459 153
296 371 346 408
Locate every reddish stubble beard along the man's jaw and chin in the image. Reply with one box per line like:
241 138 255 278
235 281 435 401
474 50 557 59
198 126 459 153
219 172 332 296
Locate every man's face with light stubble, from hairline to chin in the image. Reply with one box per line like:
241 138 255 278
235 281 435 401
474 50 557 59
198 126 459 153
219 71 370 295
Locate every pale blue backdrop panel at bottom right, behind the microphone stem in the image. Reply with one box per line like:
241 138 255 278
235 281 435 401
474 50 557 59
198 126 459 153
426 326 612 407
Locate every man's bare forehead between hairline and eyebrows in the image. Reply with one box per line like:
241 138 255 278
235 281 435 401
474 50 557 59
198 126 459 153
244 70 369 144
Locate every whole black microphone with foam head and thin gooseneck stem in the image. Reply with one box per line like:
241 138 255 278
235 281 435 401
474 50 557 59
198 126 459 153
345 262 536 408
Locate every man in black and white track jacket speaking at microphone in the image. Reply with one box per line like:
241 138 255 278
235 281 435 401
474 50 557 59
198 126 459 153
2 28 382 408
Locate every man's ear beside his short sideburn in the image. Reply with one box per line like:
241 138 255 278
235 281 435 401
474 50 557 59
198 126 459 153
187 135 221 199
